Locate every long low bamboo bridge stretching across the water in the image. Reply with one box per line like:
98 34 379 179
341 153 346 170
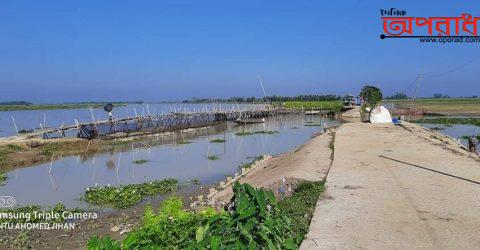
12 106 299 139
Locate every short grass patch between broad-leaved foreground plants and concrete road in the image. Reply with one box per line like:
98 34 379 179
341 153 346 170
279 181 325 243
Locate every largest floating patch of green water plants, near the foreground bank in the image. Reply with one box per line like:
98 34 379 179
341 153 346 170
84 179 178 208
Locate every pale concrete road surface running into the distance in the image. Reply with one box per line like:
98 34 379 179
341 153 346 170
301 123 480 249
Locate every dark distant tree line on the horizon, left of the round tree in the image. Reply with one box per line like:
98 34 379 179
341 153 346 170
182 95 342 103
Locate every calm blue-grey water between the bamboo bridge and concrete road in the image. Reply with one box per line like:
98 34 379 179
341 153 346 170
0 112 339 207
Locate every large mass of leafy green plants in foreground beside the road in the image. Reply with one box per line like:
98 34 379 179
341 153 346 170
88 182 324 249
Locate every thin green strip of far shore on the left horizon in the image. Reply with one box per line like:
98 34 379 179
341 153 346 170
0 102 127 111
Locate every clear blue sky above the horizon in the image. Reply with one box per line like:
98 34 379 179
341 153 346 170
0 0 480 102
